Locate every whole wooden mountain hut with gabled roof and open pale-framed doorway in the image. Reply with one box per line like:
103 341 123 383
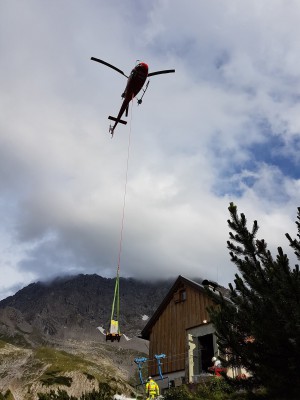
142 276 224 386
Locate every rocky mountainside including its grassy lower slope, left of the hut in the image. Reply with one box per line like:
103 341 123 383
0 275 174 400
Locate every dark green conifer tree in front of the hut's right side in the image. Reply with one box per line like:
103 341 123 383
210 203 300 399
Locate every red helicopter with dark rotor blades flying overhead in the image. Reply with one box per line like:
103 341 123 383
91 57 175 137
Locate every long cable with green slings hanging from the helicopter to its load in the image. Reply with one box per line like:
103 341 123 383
110 97 133 335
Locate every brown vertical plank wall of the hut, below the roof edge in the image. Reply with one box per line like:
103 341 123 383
148 285 212 375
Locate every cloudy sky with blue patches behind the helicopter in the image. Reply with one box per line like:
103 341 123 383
0 0 300 299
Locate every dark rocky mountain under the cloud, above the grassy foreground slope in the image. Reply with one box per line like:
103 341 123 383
0 275 173 342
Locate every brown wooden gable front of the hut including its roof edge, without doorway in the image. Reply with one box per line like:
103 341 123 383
142 275 213 375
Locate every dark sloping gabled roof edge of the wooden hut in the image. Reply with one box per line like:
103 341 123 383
141 275 205 340
